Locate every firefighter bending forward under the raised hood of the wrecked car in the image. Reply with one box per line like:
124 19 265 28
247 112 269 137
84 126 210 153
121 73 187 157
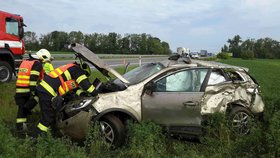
32 63 97 137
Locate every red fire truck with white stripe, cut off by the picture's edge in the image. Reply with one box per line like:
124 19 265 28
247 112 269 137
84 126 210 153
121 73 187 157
0 10 26 83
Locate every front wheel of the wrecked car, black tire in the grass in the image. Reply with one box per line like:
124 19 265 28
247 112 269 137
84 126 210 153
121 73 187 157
99 114 125 147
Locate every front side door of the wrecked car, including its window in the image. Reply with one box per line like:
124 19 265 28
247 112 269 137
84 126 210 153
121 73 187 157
142 68 209 132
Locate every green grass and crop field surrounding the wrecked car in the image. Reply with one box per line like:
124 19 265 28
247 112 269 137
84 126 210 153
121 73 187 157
0 59 280 158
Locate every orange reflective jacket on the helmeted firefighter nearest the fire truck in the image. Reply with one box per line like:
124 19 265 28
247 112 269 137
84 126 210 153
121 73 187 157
16 60 44 95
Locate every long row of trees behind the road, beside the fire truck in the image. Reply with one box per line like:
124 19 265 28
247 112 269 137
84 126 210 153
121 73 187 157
24 31 171 54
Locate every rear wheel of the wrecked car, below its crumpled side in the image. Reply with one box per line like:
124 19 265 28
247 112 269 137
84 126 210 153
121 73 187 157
229 106 253 136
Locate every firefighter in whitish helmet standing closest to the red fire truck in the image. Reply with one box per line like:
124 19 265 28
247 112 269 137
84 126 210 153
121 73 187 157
15 49 51 134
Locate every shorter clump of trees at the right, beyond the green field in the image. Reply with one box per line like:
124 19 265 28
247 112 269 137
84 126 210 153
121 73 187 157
221 35 280 59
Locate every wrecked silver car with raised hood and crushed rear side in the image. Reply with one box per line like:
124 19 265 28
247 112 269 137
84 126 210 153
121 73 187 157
58 44 264 146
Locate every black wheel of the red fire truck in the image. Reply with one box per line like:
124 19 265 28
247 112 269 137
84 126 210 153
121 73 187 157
0 61 13 82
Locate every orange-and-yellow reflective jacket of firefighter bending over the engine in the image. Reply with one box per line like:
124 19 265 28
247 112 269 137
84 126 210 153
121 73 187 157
37 64 94 96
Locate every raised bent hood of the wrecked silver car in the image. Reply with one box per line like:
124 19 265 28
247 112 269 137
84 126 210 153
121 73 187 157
70 43 129 84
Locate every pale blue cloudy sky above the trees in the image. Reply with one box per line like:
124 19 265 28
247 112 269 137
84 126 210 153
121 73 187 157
0 0 280 53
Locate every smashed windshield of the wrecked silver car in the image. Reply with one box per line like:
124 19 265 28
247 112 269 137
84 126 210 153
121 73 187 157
114 63 165 85
